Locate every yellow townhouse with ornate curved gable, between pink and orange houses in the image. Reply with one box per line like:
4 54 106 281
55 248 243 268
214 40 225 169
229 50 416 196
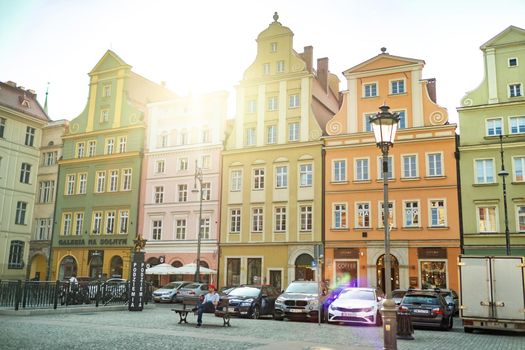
219 13 339 290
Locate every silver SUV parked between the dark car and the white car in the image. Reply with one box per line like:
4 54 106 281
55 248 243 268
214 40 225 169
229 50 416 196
274 281 319 320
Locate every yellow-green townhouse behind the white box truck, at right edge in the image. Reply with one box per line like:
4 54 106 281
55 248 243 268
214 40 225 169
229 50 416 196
458 26 525 256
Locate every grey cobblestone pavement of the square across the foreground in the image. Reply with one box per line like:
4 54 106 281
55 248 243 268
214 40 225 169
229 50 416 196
0 305 525 350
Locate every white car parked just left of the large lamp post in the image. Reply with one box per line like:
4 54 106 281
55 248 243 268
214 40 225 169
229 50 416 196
327 288 384 326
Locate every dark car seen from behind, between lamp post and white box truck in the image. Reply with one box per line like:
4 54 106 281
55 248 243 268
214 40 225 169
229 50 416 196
399 289 454 330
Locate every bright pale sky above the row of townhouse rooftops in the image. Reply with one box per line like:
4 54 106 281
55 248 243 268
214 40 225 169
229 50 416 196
0 0 525 123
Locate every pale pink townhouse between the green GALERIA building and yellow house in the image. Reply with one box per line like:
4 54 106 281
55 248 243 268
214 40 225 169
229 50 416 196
139 92 228 281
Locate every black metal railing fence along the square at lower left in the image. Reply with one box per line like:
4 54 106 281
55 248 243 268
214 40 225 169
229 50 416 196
0 280 153 310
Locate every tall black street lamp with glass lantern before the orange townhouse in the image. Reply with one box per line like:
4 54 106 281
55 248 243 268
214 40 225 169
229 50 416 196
369 105 399 349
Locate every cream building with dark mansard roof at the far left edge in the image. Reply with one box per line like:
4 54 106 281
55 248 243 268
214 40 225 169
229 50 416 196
0 81 50 280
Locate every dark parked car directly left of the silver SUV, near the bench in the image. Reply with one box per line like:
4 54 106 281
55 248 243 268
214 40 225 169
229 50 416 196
220 285 279 319
